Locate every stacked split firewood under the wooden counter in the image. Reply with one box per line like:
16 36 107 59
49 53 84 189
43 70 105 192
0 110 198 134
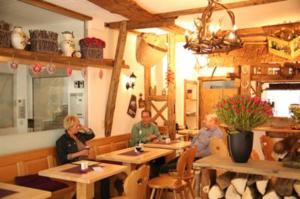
208 171 300 199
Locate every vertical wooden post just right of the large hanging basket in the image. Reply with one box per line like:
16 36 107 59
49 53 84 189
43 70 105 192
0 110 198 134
168 33 176 140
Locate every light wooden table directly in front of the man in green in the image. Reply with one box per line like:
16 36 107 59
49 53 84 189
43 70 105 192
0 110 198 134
96 147 174 173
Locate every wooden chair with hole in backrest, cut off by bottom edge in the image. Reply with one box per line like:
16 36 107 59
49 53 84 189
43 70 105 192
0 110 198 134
113 165 150 199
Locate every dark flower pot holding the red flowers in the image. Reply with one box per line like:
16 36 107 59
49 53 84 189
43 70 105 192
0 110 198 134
227 131 253 163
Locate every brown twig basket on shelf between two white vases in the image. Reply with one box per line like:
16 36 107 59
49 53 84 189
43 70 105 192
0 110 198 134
29 30 58 53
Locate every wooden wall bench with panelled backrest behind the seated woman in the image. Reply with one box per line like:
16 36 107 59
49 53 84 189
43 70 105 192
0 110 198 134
0 134 130 198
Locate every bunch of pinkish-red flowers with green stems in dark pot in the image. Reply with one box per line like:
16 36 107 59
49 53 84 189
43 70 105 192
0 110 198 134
216 95 273 133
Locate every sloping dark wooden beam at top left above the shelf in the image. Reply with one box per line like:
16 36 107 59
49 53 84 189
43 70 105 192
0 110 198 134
20 0 93 21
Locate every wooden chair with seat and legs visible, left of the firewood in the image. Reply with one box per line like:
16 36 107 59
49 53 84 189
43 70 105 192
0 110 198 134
148 150 190 199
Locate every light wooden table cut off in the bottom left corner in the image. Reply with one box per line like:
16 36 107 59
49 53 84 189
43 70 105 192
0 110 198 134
0 182 51 199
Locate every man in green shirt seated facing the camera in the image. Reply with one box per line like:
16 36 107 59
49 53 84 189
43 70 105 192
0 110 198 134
129 110 161 146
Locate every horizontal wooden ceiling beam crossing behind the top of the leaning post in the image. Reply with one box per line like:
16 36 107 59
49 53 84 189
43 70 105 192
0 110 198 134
105 17 175 30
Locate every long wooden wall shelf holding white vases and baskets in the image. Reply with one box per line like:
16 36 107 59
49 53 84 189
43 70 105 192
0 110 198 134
0 48 129 69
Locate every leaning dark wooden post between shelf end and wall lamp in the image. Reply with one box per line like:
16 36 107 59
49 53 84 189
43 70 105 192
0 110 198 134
105 21 127 137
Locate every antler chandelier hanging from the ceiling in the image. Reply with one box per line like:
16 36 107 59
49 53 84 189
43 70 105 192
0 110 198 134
184 0 242 54
